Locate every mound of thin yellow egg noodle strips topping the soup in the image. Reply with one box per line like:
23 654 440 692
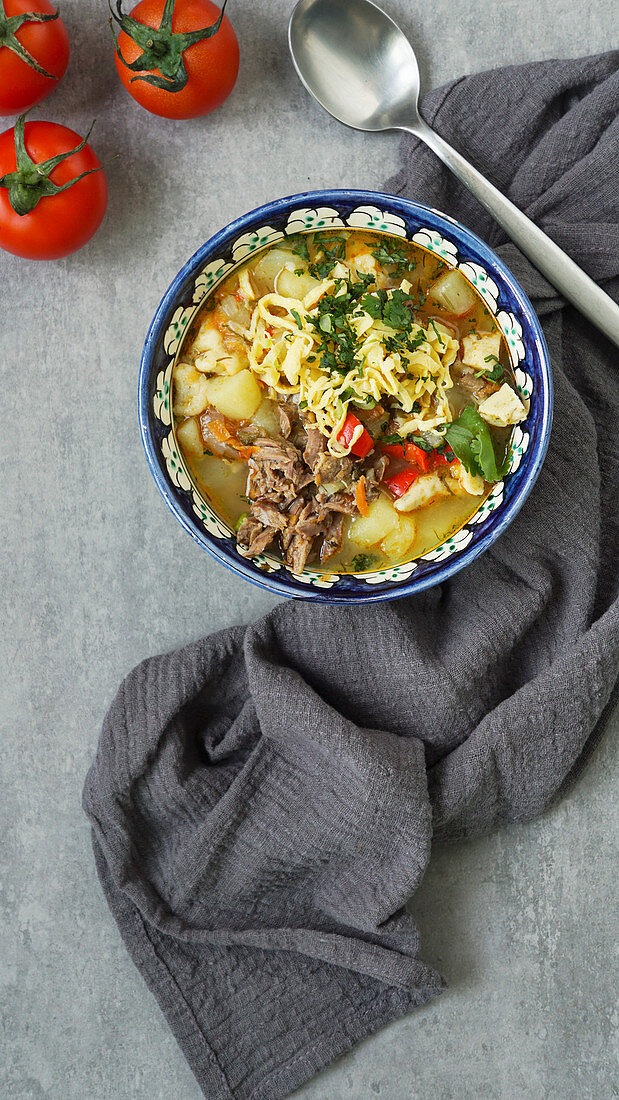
213 255 458 455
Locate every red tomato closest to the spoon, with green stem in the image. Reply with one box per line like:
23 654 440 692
115 0 239 119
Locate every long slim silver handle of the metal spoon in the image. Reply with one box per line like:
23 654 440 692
406 119 619 347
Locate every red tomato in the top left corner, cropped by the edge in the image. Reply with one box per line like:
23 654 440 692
0 0 69 114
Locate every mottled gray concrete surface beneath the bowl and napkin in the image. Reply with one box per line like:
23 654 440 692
0 0 617 1100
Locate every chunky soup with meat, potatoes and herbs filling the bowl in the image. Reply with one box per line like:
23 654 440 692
173 230 528 573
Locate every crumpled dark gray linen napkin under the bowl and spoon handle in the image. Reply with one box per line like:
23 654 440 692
84 54 619 1100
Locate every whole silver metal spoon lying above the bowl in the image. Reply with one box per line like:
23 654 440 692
288 0 619 345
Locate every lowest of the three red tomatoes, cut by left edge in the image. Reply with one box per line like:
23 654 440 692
0 122 108 260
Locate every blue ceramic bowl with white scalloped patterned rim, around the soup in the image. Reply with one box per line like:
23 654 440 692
139 190 552 603
